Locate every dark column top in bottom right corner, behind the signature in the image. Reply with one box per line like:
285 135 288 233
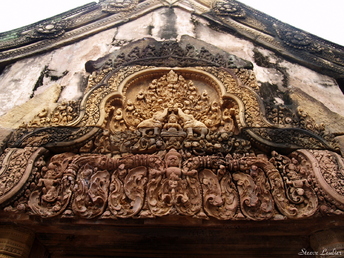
310 228 344 258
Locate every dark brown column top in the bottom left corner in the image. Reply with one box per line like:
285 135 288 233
0 225 35 258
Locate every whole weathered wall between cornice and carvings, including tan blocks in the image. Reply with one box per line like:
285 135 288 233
0 8 344 133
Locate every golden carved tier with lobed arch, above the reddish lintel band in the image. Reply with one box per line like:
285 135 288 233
27 66 336 153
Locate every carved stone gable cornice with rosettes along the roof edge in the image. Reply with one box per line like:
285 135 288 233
0 0 344 79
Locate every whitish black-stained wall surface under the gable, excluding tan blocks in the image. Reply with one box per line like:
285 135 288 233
0 8 344 125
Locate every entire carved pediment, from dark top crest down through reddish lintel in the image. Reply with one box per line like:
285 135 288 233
0 40 344 220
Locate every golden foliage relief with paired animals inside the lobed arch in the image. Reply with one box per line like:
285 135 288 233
109 70 221 132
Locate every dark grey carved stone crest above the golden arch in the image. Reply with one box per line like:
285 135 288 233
86 36 253 77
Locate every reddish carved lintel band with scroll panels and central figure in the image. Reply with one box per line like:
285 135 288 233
2 149 343 220
